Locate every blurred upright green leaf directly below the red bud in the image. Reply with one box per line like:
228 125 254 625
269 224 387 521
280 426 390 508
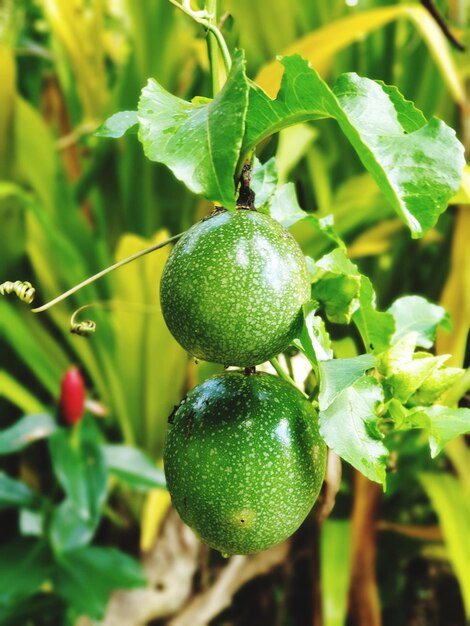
49 418 108 525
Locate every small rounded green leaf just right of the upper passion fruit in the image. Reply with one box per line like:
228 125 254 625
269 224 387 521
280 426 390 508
312 248 361 324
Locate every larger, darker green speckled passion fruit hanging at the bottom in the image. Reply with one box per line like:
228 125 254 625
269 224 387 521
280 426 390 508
164 371 326 554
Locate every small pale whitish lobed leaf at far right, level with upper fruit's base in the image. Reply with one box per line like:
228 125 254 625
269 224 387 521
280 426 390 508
388 296 452 348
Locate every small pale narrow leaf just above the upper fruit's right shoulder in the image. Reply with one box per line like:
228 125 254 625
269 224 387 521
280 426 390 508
269 183 345 248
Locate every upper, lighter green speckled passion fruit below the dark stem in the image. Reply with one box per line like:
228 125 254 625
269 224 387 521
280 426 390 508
160 209 310 367
